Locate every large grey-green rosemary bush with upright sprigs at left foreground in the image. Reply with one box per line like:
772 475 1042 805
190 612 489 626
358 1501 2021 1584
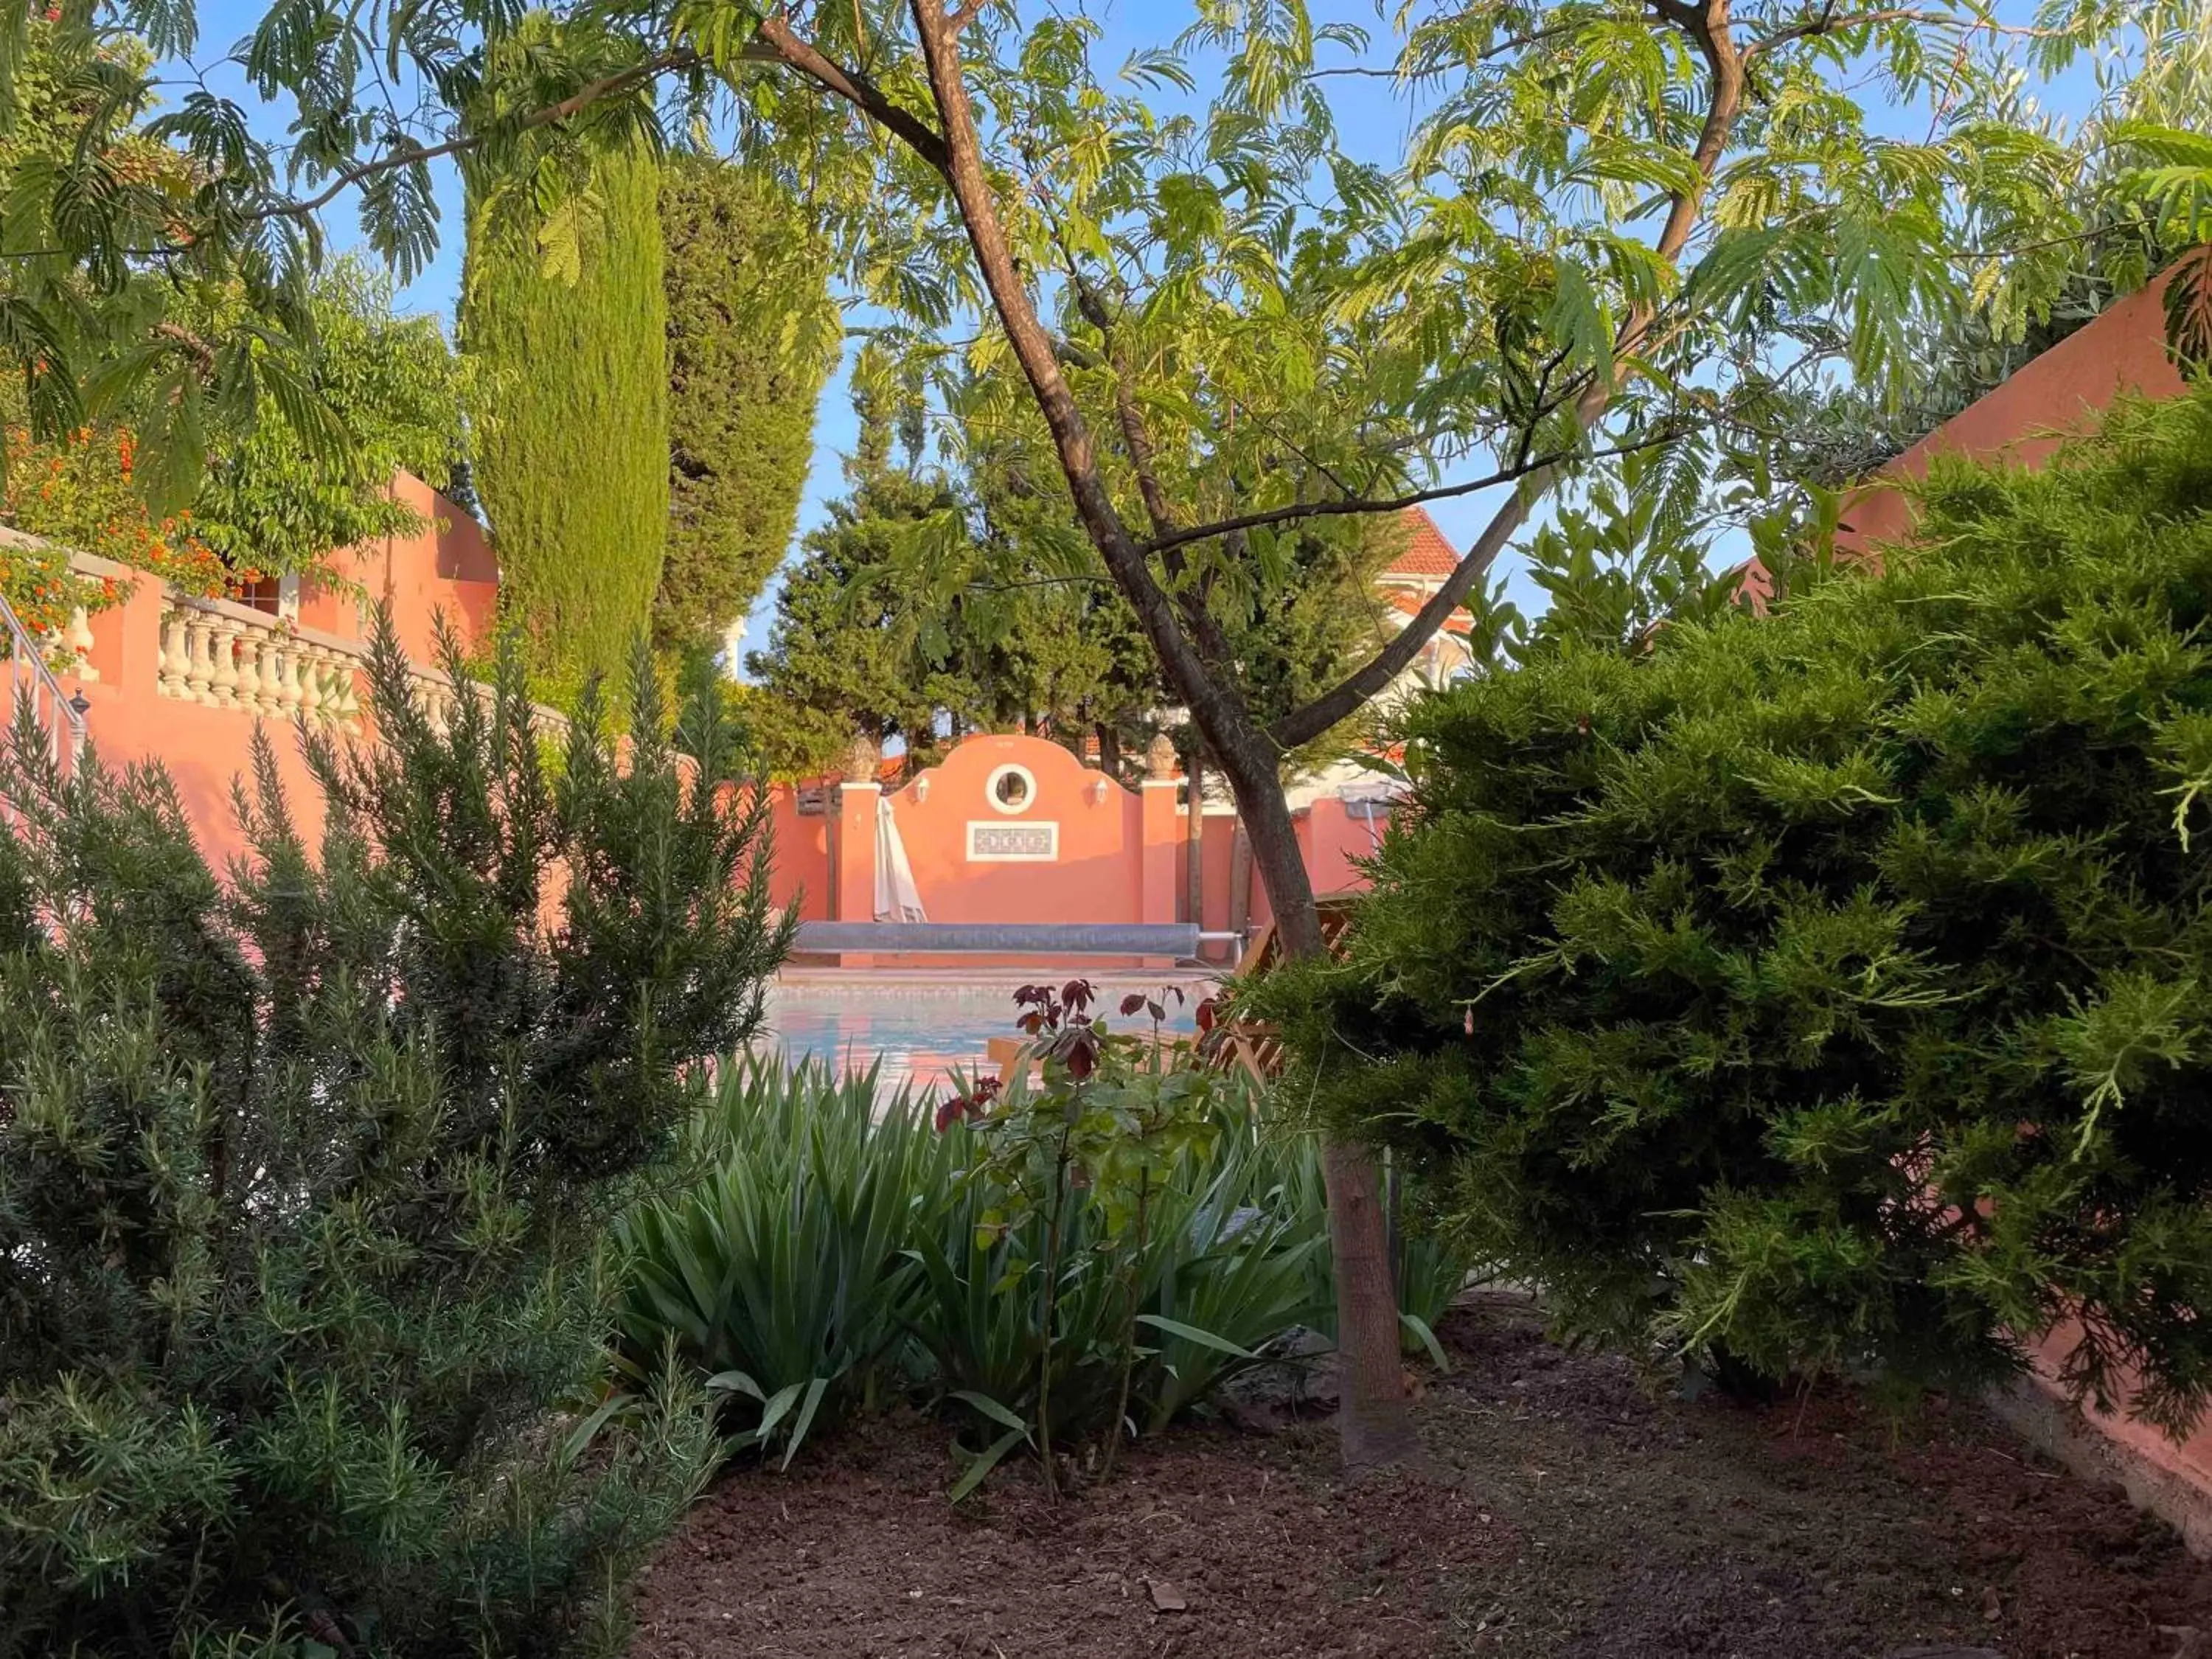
0 622 787 1659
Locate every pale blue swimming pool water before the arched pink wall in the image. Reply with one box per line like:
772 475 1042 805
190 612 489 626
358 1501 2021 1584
757 973 1210 1093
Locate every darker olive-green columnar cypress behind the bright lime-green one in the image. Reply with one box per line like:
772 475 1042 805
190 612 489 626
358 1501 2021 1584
653 155 838 657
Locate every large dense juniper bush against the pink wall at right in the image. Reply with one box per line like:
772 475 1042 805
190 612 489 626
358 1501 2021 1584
1252 389 2212 1422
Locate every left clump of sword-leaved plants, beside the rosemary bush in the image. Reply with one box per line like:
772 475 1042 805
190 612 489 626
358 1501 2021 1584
619 1055 956 1462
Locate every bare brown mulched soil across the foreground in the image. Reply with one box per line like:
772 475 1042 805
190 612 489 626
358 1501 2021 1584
633 1296 2212 1659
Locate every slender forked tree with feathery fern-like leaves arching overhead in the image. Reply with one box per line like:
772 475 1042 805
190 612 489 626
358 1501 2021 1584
7 0 2177 1462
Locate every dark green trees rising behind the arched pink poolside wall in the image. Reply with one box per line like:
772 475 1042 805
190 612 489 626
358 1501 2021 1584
748 420 1402 772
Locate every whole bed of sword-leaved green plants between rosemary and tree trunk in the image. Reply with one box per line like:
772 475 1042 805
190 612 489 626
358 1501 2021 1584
619 1000 1327 1491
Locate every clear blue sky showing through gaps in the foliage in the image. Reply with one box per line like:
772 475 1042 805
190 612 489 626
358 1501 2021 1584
164 0 2093 677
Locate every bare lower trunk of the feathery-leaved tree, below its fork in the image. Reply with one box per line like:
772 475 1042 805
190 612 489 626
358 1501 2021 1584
1214 732 1420 1469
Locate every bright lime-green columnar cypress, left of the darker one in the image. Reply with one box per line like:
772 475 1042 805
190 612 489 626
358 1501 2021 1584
462 139 668 684
